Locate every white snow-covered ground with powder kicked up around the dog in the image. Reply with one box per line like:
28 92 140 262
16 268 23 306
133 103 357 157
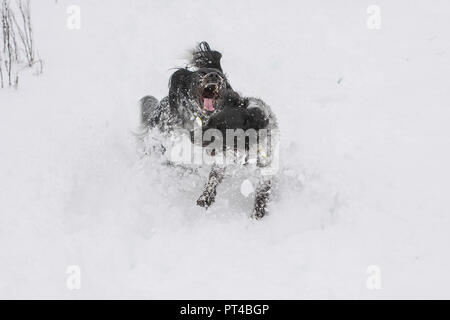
0 0 450 299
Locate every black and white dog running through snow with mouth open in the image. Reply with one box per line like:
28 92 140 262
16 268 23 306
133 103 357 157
140 42 277 219
